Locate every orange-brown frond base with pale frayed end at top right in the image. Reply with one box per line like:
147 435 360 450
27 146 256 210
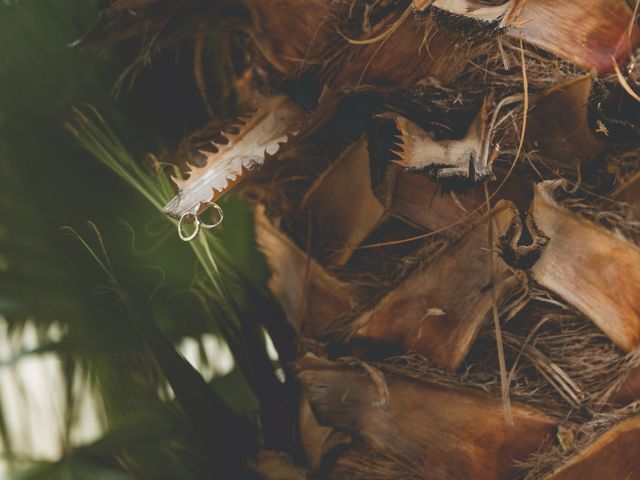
414 0 640 73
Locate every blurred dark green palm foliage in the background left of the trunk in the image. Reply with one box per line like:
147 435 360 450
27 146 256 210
0 0 286 480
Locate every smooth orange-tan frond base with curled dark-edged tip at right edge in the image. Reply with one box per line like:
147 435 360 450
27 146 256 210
507 181 640 352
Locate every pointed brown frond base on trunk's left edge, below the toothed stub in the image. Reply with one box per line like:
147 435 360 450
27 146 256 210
255 206 357 337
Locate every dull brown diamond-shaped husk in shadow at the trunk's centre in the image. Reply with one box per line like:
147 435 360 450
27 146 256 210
301 138 385 265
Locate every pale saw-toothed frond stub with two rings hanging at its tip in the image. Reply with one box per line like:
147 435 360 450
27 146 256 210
163 95 303 219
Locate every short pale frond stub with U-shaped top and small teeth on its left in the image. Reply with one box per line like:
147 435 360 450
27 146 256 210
382 97 492 182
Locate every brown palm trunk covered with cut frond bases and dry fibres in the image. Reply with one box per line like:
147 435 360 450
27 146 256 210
89 0 640 480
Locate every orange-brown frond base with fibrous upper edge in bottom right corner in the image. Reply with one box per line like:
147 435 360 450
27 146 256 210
518 402 640 480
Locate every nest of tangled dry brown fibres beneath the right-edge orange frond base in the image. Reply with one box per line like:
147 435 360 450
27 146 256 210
464 290 633 414
